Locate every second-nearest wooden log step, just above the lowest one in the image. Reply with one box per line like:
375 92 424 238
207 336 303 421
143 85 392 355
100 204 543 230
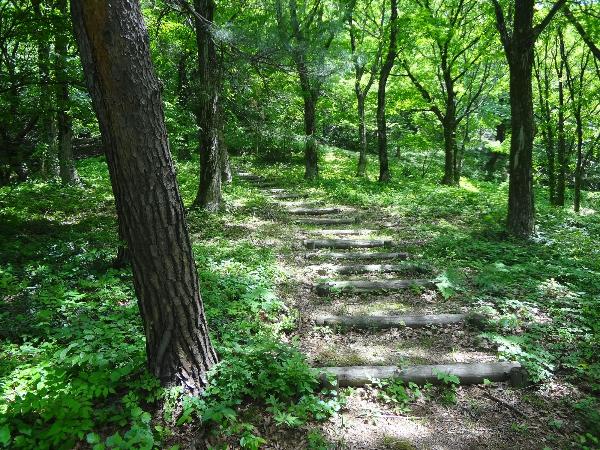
315 314 469 329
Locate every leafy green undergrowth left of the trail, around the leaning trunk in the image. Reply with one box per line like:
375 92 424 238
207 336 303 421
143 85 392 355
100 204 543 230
0 159 340 449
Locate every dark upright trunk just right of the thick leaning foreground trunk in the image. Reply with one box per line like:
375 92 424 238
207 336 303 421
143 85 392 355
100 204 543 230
194 0 222 211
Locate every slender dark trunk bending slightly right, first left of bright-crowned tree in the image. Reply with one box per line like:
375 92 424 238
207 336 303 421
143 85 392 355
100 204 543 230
377 0 398 182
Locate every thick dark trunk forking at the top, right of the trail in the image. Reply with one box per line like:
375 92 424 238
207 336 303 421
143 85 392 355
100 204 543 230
493 0 566 237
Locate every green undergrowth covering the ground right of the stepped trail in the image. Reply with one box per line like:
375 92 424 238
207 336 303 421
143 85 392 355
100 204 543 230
238 148 600 442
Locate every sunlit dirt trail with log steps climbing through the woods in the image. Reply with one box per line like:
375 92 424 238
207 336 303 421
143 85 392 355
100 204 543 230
239 170 568 449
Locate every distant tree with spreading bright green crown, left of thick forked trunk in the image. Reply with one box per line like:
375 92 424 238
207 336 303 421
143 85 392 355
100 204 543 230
402 0 491 185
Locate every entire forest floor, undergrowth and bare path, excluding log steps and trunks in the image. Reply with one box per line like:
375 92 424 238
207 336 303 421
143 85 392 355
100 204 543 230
0 150 600 449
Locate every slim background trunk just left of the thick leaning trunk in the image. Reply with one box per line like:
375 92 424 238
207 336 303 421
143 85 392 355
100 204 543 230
54 0 80 185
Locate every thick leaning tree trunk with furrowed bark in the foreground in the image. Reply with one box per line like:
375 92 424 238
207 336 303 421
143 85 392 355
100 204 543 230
71 0 217 394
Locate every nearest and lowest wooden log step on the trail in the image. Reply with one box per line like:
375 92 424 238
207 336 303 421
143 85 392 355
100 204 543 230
318 362 527 387
